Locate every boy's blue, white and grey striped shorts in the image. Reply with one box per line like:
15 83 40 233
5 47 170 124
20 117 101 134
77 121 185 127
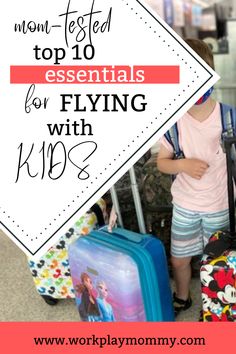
171 204 229 258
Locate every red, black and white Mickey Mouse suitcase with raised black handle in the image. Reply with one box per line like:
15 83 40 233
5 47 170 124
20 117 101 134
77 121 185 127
200 137 236 322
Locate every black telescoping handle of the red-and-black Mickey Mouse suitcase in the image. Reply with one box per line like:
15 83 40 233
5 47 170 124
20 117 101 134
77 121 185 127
224 137 236 236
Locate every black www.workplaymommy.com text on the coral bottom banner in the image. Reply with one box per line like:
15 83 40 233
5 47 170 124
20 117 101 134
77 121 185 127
34 334 206 348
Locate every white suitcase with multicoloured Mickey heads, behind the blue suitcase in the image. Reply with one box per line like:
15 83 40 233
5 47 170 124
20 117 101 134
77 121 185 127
28 199 106 305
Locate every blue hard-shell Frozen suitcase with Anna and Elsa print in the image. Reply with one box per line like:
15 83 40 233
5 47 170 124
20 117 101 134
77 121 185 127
69 227 174 322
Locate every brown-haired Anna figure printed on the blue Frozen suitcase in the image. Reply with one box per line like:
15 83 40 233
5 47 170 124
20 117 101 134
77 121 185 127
75 273 100 322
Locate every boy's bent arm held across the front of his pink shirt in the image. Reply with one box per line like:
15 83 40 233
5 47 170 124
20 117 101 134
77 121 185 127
157 144 209 179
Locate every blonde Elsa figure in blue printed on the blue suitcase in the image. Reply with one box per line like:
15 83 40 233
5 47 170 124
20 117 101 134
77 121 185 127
97 281 115 322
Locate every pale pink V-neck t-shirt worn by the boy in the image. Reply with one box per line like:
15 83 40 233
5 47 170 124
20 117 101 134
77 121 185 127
161 103 228 212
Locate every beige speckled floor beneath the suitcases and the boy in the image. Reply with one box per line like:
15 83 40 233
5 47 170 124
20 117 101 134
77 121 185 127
0 231 201 322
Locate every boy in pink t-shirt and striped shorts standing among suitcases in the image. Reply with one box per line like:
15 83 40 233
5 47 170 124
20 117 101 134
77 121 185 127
157 39 229 315
